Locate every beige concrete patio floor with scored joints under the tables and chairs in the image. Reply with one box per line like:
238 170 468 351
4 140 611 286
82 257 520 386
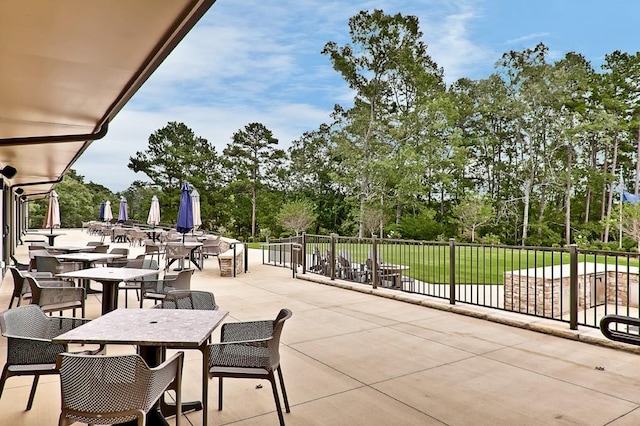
0 229 640 426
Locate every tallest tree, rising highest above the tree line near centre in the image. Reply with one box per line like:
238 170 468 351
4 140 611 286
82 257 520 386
322 10 442 236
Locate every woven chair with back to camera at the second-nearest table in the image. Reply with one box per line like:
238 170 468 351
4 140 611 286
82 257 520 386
24 276 85 318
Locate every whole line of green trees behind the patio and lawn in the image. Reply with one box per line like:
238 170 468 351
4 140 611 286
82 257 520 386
30 10 640 247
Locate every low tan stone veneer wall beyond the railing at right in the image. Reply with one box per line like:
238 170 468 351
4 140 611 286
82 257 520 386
504 271 638 317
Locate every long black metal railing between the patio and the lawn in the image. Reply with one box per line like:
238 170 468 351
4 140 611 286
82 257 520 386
263 234 640 329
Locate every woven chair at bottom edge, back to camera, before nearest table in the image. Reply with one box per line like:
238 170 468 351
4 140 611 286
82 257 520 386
57 352 184 426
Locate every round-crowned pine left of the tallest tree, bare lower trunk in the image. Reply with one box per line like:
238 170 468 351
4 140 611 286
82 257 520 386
223 123 287 237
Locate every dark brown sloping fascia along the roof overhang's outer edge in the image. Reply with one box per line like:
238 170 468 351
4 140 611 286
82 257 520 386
102 0 216 125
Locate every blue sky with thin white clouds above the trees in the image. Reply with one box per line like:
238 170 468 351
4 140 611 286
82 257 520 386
73 0 640 192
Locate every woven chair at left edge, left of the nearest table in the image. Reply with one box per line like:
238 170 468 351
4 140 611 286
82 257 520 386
0 305 102 410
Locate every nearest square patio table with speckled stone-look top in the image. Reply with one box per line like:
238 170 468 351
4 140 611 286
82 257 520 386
53 308 228 426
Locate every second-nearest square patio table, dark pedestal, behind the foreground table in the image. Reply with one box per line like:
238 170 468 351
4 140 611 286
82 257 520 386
56 268 158 315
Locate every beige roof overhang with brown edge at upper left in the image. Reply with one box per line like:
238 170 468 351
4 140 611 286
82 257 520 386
0 0 215 195
